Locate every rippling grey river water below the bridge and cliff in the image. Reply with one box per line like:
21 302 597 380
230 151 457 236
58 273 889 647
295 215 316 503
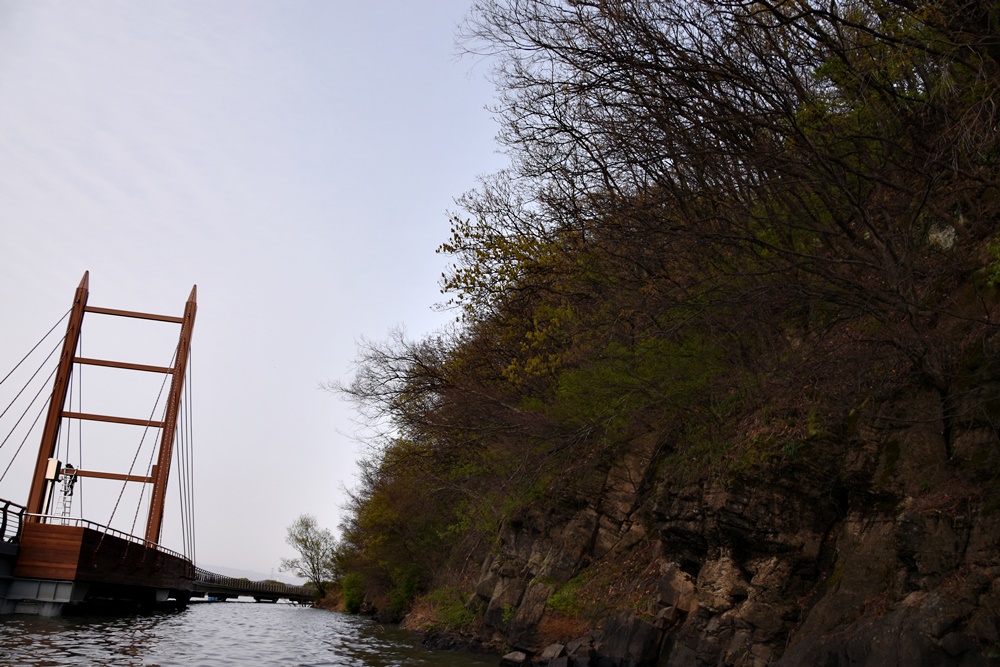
0 601 500 667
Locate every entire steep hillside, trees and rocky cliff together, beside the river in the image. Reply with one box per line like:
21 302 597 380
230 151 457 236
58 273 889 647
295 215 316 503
340 0 1000 666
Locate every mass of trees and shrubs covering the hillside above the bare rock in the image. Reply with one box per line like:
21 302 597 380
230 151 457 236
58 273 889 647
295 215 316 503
329 0 1000 620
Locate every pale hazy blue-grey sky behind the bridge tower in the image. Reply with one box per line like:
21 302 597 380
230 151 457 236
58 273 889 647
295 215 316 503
0 0 506 575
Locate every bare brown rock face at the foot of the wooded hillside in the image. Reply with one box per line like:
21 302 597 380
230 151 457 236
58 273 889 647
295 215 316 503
468 391 1000 667
